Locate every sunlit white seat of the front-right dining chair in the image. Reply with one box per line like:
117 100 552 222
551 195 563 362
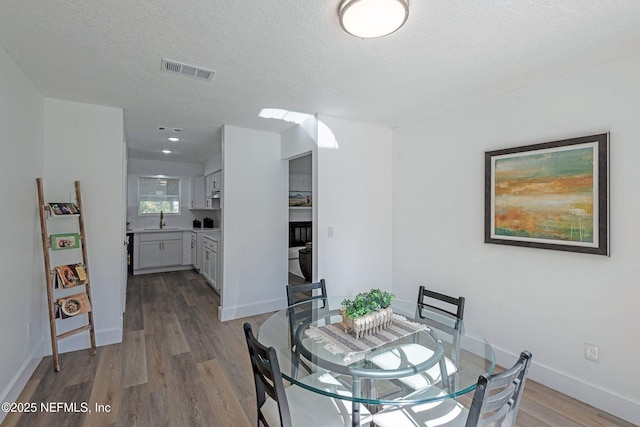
373 387 468 427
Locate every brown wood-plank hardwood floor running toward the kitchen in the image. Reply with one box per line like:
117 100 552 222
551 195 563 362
2 271 633 427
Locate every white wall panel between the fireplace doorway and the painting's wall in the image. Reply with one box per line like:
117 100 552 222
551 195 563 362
314 116 392 295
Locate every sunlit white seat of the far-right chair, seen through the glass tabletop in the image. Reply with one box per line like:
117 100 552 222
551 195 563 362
371 343 458 390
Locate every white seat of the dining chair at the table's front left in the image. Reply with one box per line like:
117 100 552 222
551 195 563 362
261 373 372 427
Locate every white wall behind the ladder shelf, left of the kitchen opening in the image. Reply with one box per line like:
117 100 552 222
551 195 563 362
44 99 125 353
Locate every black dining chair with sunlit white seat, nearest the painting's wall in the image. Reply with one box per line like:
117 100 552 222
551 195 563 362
371 286 465 390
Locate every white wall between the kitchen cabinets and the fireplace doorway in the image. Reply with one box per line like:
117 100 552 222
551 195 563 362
220 126 289 320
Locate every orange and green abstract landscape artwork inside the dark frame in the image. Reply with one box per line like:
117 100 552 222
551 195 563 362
493 144 598 244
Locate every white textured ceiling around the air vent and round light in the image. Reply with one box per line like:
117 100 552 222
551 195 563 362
0 0 640 162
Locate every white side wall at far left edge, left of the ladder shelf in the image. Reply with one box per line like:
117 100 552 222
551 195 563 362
0 41 49 421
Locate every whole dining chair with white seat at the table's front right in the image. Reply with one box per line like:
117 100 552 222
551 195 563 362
373 351 532 427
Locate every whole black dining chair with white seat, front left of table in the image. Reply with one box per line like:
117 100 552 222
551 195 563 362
244 323 371 427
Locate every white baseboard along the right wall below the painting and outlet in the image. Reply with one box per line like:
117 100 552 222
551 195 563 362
494 347 640 425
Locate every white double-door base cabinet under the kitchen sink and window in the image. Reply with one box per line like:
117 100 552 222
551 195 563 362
136 232 182 269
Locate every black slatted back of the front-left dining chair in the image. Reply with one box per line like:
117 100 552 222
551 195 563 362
244 323 292 427
